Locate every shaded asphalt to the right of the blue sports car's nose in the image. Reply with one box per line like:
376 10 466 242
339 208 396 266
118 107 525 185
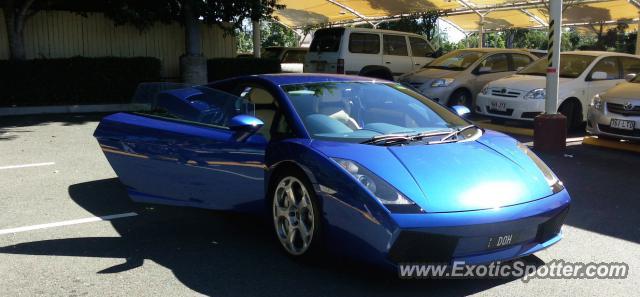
538 145 640 243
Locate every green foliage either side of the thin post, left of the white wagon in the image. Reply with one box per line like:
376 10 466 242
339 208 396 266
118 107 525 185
236 22 298 53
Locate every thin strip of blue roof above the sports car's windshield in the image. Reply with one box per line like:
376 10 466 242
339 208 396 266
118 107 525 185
256 73 387 85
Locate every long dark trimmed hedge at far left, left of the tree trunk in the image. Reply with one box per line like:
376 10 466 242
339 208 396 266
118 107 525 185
0 57 161 107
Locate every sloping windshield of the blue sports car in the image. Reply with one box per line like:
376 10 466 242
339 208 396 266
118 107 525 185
282 82 478 142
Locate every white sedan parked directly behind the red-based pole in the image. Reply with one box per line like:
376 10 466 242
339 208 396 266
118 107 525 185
475 51 640 128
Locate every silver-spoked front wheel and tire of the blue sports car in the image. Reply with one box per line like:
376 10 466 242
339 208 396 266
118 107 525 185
271 171 322 258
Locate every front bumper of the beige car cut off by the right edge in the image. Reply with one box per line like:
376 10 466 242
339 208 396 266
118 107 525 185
587 106 640 140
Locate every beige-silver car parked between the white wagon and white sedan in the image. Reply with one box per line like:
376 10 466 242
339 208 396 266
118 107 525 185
399 48 537 108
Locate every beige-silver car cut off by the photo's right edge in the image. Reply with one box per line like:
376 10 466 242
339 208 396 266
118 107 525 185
587 73 640 140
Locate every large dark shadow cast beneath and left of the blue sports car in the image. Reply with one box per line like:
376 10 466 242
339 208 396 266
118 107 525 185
0 178 544 296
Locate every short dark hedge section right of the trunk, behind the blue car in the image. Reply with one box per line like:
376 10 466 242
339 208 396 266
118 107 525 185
207 58 281 81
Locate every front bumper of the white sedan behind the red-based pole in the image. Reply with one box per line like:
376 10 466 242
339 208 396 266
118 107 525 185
475 93 544 121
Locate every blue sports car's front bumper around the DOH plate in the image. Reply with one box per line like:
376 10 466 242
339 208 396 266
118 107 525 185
387 190 571 265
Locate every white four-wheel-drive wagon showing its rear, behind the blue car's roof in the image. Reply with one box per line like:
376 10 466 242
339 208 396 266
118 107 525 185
304 28 435 80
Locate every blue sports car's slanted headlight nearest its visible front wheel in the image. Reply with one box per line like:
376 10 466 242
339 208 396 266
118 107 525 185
333 158 424 213
